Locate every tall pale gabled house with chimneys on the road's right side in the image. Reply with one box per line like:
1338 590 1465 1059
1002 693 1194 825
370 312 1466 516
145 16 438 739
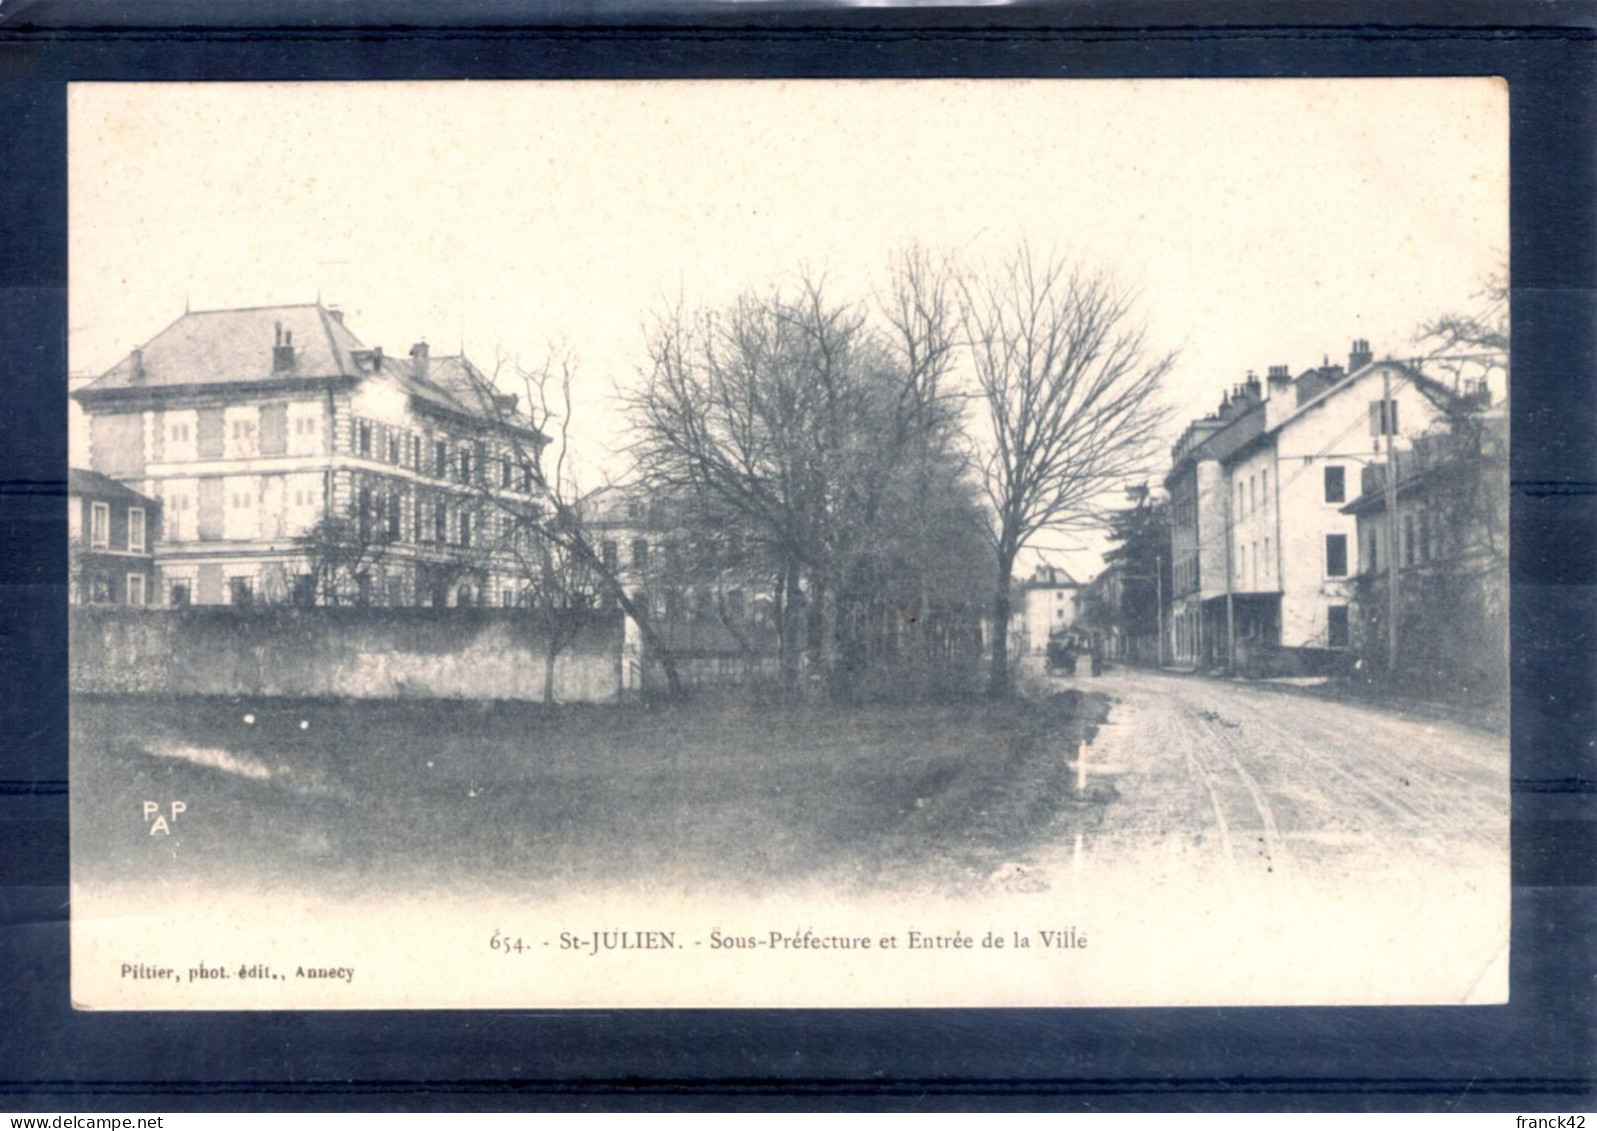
1166 340 1450 668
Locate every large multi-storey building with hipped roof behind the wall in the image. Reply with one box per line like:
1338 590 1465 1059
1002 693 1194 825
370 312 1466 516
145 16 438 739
72 304 546 605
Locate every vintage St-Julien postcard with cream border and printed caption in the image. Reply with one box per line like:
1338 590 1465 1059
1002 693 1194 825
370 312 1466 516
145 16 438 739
65 78 1511 1010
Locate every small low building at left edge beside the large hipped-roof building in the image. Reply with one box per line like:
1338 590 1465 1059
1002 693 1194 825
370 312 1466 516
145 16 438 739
67 468 161 605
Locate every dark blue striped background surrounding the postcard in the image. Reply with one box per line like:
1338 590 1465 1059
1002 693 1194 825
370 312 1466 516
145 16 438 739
0 0 1597 1112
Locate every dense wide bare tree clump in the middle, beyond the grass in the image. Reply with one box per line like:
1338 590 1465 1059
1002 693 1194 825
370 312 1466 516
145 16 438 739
629 260 961 698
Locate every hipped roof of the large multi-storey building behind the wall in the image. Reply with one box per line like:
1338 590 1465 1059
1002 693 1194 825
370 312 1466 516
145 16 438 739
73 302 537 431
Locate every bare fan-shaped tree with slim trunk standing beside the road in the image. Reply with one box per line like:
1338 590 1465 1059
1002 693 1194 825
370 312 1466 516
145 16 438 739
961 246 1175 696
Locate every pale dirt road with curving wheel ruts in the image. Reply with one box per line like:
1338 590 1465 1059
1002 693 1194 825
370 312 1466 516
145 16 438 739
1051 668 1509 882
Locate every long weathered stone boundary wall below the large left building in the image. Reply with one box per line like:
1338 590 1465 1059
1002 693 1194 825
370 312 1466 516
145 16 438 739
69 607 623 703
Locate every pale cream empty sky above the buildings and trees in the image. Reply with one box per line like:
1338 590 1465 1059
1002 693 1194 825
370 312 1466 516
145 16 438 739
69 78 1508 578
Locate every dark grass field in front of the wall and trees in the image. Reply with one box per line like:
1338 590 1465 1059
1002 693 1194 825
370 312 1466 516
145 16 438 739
72 692 1105 891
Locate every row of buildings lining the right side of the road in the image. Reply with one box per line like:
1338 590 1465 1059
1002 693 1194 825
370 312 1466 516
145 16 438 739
1078 340 1508 679
